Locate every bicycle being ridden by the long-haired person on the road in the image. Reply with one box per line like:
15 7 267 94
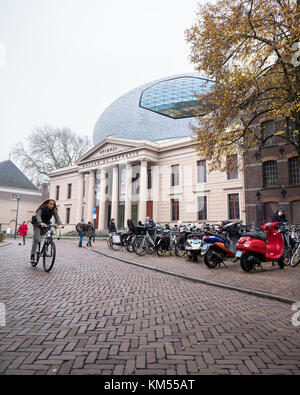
31 225 62 273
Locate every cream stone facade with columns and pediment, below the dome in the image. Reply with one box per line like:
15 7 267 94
50 136 245 231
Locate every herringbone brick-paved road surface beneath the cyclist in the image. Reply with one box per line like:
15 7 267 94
0 240 300 375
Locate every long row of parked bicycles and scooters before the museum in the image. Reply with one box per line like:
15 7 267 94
107 220 300 272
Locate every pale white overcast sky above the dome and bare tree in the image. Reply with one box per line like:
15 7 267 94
0 0 204 161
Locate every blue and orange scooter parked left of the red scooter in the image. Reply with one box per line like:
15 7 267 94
202 221 242 269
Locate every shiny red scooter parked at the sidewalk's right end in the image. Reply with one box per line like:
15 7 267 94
235 222 284 272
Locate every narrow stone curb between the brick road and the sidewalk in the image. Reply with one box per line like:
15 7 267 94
91 249 298 304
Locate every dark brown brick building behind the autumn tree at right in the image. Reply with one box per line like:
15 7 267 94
244 119 300 225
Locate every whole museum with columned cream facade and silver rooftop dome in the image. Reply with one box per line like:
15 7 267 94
50 73 245 231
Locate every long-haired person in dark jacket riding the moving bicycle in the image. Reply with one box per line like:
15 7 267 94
30 199 63 262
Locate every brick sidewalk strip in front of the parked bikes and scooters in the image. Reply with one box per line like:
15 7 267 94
92 240 300 303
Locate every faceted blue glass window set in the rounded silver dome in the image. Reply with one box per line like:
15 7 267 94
140 77 213 119
